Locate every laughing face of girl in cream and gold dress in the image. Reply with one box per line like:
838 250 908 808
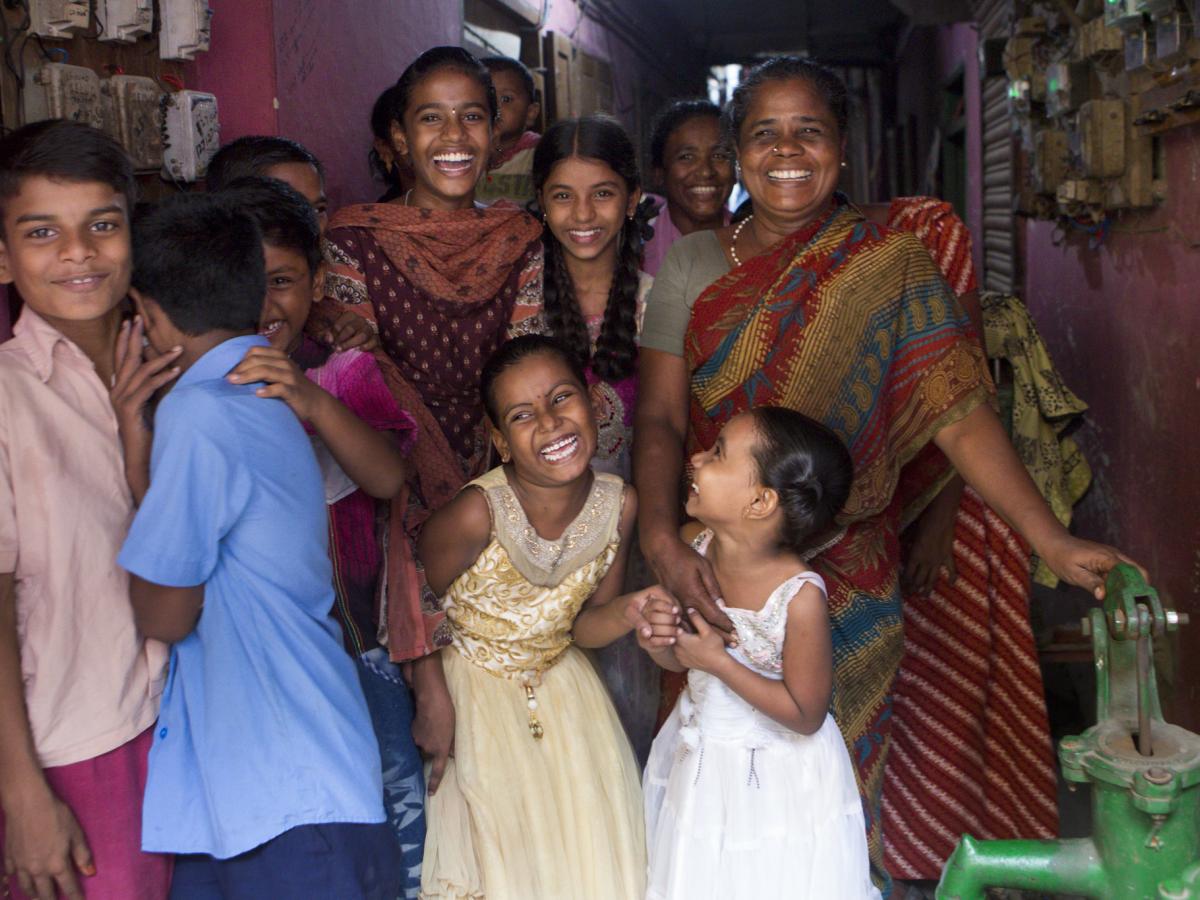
492 353 596 486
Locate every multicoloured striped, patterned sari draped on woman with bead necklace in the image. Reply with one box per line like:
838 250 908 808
684 196 990 877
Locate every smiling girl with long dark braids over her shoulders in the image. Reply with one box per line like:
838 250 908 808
533 116 658 762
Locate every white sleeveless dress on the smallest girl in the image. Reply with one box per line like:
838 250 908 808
643 532 880 900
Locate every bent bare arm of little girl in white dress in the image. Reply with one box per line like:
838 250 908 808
676 584 833 734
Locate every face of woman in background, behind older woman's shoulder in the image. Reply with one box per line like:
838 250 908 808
659 115 733 234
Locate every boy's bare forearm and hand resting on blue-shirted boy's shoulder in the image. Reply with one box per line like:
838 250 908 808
228 347 408 499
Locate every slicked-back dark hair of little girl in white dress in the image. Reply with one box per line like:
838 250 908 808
750 407 854 553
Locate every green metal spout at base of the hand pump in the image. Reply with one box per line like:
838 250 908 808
936 835 1106 900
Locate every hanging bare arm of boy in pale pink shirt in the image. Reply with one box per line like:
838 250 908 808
0 572 96 900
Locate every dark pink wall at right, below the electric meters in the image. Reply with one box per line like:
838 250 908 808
1025 127 1200 731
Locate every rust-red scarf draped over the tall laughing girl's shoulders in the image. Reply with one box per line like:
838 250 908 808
307 203 541 661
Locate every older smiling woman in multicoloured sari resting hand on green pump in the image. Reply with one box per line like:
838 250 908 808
634 58 1137 897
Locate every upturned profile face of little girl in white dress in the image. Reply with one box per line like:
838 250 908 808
686 413 762 526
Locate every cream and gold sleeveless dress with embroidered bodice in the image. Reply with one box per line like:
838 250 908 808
421 468 646 900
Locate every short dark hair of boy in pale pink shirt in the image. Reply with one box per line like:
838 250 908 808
0 119 138 227
